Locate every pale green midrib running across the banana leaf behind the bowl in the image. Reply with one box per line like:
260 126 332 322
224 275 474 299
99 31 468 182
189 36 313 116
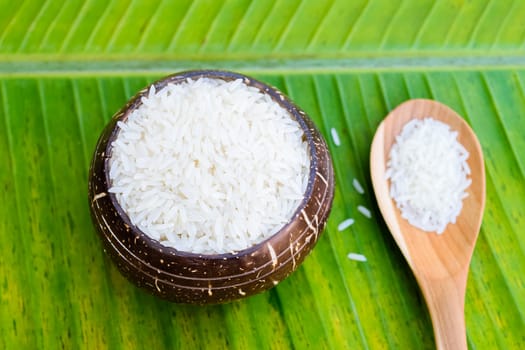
0 51 525 77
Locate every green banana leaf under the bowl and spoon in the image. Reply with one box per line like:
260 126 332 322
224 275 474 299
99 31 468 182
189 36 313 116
0 0 525 349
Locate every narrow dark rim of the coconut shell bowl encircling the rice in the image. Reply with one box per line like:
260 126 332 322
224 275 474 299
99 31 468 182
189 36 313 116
103 69 319 260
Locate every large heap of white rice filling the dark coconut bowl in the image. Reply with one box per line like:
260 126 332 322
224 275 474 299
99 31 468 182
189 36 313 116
109 78 310 254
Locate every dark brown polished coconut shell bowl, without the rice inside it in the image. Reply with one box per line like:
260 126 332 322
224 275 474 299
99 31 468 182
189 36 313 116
88 70 334 304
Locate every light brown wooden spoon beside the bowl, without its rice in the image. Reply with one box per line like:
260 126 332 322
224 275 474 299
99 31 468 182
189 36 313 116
370 99 485 349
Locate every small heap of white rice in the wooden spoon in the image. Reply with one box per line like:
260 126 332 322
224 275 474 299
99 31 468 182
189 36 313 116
386 118 471 234
